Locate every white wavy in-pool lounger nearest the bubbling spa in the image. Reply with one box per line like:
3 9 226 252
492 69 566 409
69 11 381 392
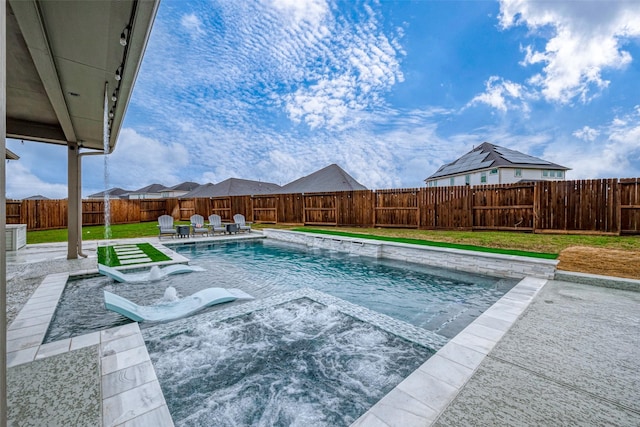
104 288 253 322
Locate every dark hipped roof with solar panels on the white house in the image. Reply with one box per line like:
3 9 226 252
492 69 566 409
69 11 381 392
427 142 570 180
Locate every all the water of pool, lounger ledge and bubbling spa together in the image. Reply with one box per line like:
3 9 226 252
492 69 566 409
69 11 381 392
46 240 516 427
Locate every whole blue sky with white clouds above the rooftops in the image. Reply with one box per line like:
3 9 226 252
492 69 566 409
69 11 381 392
6 0 640 199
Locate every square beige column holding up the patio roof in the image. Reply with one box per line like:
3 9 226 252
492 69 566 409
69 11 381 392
67 142 82 259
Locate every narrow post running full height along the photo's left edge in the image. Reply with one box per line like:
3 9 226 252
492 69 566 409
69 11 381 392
0 1 7 427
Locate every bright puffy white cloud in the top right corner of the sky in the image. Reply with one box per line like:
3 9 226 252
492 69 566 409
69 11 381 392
499 0 640 103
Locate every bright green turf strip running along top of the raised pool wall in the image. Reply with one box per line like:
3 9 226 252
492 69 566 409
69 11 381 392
292 227 558 259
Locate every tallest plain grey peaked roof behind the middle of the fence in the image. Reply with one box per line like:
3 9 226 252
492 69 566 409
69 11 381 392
278 163 367 194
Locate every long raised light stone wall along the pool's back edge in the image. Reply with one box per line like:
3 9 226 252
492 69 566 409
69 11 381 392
262 228 558 279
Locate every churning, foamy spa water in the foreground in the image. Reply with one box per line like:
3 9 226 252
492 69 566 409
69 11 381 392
143 298 433 427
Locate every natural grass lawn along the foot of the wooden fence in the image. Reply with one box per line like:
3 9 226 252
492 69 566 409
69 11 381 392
27 221 640 256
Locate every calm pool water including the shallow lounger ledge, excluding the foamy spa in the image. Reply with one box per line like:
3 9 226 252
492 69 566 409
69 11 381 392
46 240 517 342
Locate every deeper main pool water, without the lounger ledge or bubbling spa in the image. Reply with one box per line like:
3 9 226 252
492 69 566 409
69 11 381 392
176 240 517 338
